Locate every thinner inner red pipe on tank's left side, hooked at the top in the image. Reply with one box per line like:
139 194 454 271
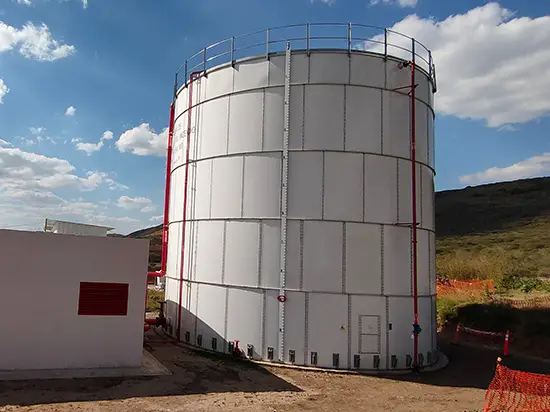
176 72 201 340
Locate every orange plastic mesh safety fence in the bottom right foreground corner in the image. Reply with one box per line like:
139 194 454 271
483 364 550 412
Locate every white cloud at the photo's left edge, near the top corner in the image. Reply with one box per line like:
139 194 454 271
0 21 76 61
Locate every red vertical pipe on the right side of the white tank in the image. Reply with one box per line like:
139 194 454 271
411 59 418 367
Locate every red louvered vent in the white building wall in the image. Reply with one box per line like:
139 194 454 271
78 282 129 316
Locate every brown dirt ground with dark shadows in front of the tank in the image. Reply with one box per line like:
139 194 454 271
0 336 550 412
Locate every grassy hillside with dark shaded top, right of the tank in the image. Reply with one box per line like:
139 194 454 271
436 178 550 280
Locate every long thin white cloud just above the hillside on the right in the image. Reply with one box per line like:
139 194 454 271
459 153 550 184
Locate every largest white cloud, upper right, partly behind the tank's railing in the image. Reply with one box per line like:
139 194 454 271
367 3 550 127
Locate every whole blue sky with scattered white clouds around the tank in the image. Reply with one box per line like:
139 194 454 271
0 0 550 233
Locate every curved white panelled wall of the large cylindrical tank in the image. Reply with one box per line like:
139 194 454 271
166 51 436 369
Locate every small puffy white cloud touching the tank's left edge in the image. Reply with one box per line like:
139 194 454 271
116 123 168 156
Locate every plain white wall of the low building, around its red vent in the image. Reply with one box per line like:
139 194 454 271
0 230 149 369
